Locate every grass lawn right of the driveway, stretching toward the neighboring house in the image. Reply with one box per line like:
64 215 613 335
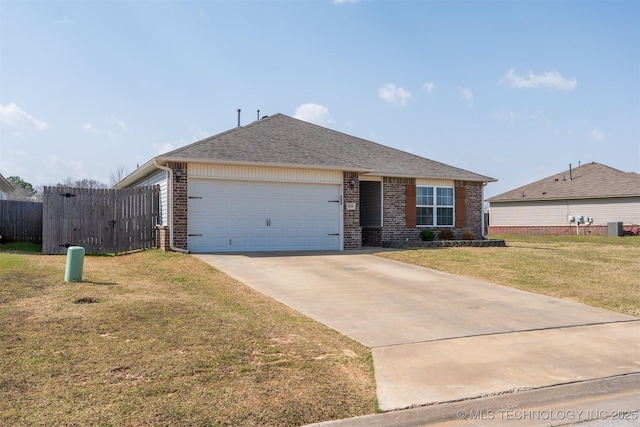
379 236 640 316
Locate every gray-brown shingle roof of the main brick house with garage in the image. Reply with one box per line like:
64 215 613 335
159 114 495 182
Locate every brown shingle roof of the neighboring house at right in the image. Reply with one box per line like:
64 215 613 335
487 162 640 202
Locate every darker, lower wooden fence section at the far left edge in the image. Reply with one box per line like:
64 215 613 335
0 200 42 243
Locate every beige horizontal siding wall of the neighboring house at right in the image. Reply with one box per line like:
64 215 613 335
489 197 640 227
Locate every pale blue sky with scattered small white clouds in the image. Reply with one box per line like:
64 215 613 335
0 0 640 197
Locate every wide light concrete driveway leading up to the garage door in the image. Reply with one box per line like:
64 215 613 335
194 251 640 410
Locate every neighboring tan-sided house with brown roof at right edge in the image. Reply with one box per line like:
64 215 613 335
487 162 640 235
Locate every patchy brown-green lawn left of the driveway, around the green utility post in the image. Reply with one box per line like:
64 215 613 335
0 251 377 426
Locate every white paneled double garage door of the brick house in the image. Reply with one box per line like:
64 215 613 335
188 179 342 252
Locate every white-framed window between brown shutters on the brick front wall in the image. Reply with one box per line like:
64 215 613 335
416 186 454 227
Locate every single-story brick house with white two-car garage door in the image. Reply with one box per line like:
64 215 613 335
115 114 495 252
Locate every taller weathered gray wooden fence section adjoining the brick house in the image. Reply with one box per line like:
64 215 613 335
42 186 160 254
